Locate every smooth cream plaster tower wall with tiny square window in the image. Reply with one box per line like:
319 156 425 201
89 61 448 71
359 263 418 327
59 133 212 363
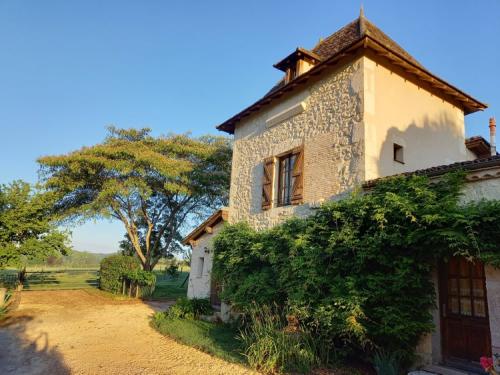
363 56 471 180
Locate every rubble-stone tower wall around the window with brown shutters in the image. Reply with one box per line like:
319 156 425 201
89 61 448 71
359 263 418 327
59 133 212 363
229 59 364 229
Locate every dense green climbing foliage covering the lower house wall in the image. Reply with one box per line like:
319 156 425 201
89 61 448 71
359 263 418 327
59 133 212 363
213 173 500 360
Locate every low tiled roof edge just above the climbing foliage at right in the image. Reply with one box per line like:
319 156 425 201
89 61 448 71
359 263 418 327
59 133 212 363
363 155 500 189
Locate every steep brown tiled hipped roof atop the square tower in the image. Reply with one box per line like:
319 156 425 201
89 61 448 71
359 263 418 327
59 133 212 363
217 15 487 133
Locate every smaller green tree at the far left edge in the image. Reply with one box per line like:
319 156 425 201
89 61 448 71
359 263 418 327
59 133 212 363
0 181 69 268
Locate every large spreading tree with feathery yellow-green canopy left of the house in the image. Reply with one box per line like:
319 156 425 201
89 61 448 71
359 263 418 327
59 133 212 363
38 127 231 270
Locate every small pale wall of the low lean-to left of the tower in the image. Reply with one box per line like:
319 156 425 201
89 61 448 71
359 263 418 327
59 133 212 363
187 223 223 298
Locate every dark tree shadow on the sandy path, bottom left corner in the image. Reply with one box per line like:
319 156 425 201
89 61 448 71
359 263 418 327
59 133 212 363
0 314 71 375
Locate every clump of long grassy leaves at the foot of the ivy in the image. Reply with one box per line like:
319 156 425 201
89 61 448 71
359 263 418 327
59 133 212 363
240 306 319 374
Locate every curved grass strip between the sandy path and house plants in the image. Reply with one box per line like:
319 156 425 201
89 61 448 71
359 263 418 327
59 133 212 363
152 313 246 364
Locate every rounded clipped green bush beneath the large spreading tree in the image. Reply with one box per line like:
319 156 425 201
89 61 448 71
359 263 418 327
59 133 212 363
99 255 140 294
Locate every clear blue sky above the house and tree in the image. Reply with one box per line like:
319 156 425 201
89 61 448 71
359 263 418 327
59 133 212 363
0 0 500 252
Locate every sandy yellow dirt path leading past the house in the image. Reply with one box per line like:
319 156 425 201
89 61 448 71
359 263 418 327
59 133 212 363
0 290 251 375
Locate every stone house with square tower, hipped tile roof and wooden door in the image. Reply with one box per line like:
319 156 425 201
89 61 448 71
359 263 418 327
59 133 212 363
185 13 500 373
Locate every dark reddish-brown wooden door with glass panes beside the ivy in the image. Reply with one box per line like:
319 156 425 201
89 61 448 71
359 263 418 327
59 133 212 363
440 257 491 363
